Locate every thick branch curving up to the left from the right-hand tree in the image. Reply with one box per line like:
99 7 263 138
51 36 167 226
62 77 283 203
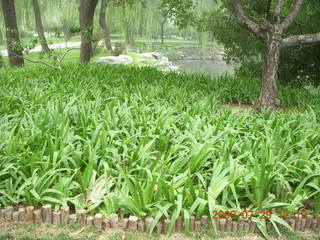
231 0 264 37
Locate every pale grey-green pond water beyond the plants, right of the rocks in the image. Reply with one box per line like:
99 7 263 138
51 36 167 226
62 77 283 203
173 56 234 76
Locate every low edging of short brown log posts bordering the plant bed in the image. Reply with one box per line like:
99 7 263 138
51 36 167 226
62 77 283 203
0 205 320 235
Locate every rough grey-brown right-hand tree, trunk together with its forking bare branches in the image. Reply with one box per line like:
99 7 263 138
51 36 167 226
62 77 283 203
231 0 320 110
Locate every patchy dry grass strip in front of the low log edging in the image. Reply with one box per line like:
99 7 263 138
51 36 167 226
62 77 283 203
0 225 317 240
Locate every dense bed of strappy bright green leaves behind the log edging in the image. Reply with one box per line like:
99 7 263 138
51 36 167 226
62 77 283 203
0 65 320 237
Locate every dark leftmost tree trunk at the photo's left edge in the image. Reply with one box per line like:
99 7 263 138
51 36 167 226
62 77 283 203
1 0 24 66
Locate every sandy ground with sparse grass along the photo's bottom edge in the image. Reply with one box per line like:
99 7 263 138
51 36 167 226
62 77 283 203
0 221 320 240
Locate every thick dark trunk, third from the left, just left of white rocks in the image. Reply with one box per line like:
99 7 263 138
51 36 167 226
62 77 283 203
79 0 98 63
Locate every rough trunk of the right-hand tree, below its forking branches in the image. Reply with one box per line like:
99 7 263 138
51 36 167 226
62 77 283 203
255 33 281 110
